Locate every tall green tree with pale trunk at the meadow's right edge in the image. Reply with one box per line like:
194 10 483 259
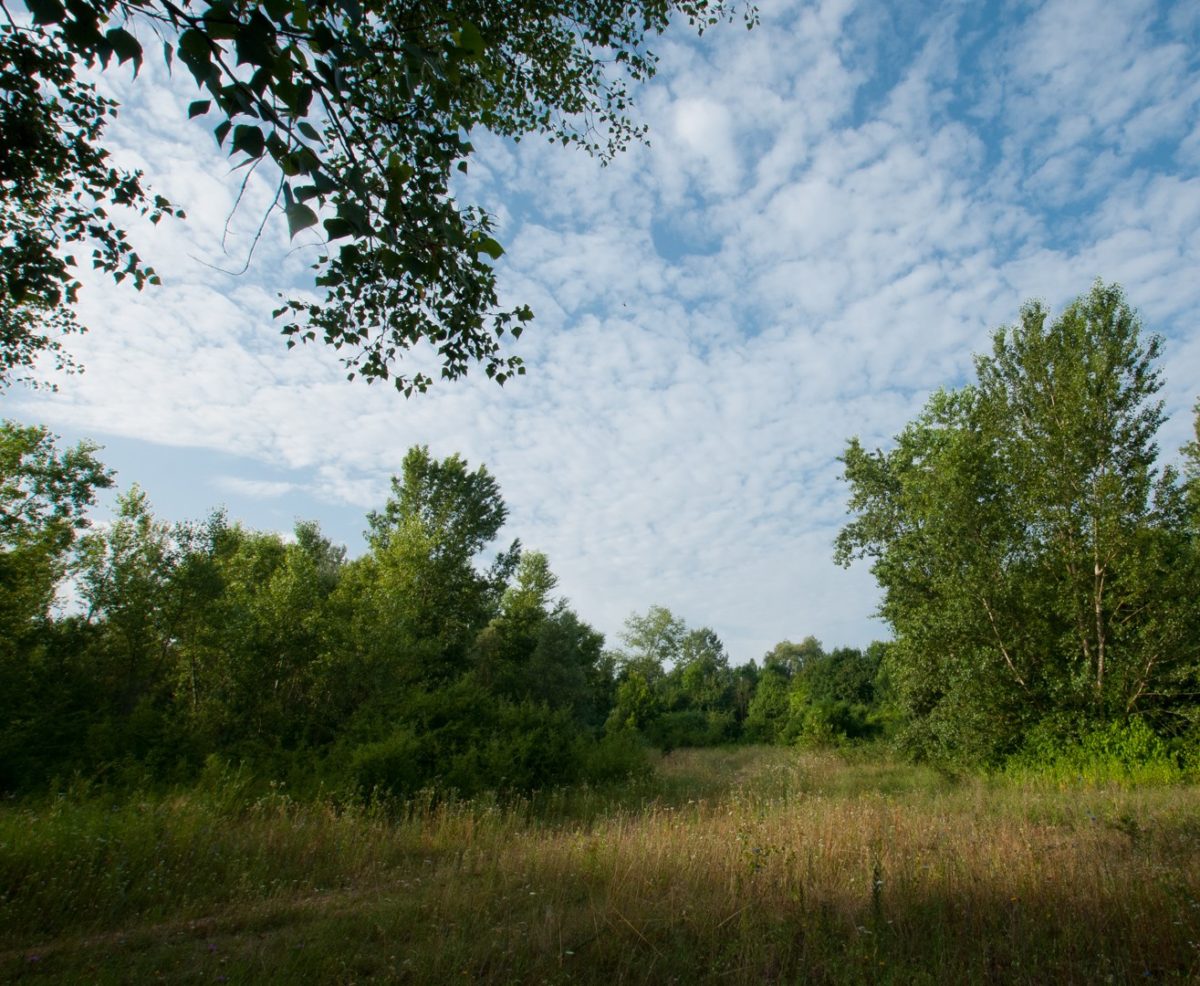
836 283 1198 758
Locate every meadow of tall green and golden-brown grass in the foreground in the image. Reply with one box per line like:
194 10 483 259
0 748 1200 984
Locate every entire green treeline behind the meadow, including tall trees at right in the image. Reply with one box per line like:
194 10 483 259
9 283 1200 796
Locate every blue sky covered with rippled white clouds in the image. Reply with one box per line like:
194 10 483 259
9 0 1200 663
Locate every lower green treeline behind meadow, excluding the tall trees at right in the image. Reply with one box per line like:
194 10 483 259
0 436 882 796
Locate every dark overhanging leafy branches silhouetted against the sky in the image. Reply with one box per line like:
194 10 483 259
0 0 756 393
